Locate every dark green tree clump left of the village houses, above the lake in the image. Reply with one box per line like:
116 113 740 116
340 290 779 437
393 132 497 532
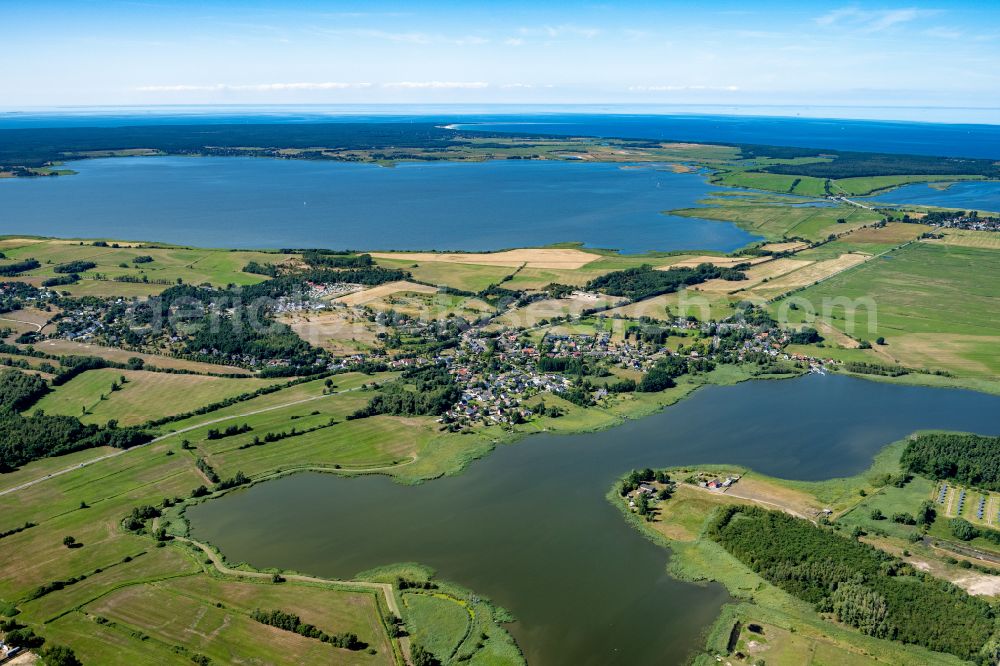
348 365 462 419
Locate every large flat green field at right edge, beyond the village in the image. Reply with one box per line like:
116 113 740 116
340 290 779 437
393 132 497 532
775 242 1000 376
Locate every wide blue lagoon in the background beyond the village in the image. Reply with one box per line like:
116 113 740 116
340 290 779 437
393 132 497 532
0 157 756 253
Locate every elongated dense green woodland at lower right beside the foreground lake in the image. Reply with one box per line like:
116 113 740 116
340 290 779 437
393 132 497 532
707 506 996 664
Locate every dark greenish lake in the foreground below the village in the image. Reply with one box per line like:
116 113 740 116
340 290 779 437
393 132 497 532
188 376 1000 665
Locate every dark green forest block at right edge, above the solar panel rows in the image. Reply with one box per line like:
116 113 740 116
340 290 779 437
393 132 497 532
900 433 1000 491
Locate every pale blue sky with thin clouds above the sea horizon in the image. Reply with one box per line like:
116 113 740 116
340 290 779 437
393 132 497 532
0 0 1000 108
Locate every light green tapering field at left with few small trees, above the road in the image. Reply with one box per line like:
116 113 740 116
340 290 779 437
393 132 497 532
33 368 279 426
